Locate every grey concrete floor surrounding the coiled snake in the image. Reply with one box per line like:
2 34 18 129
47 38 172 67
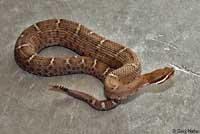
0 0 200 134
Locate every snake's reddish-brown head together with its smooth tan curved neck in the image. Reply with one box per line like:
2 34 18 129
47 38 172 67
105 67 174 100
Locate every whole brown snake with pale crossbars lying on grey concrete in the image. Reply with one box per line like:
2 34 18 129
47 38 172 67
14 19 174 110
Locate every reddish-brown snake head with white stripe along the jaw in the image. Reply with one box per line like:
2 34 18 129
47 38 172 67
144 67 175 84
